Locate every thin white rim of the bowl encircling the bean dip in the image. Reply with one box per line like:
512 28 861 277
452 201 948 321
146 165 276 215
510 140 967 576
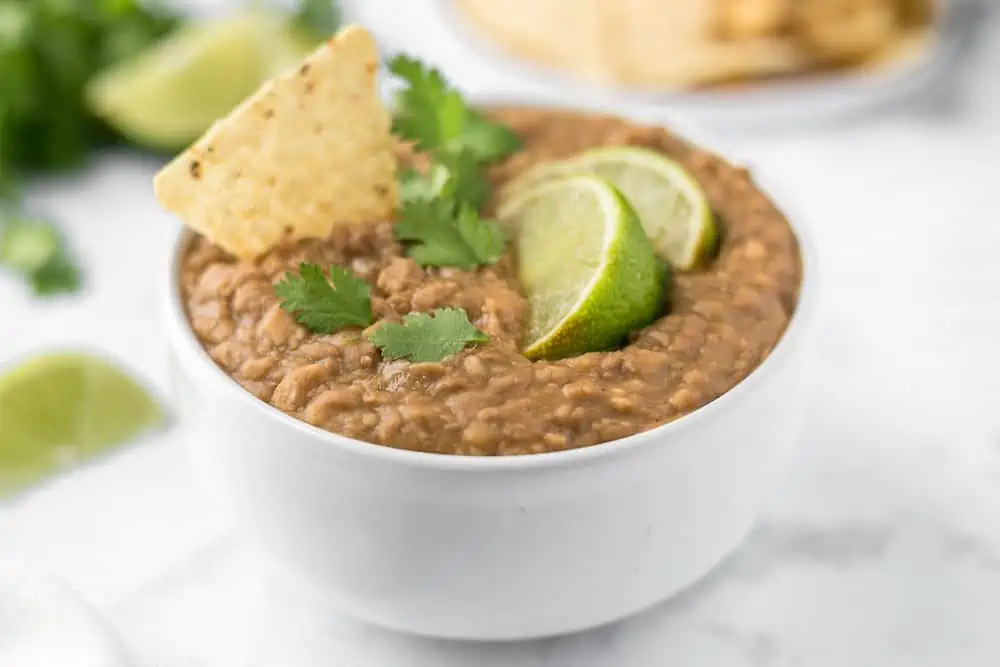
163 97 818 473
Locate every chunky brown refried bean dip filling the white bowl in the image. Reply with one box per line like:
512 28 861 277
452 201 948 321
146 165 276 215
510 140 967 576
181 108 801 455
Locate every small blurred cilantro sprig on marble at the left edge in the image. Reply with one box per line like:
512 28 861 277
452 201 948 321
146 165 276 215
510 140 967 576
0 217 80 295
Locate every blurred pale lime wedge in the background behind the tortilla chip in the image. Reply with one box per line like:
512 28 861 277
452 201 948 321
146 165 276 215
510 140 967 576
87 12 316 150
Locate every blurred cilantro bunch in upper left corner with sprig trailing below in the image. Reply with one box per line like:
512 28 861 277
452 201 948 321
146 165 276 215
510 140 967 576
0 0 175 294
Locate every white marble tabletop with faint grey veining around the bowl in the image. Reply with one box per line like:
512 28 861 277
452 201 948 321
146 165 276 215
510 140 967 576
0 0 1000 667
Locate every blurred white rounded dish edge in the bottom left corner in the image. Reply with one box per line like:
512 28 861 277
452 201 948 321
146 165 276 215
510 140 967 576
0 556 128 667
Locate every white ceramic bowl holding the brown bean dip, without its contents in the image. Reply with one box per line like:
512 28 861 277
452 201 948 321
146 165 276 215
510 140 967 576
166 109 815 640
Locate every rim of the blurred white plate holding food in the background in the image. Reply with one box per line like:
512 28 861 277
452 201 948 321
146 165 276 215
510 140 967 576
434 0 974 129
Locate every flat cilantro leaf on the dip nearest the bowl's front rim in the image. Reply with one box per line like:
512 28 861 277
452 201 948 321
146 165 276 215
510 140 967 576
368 308 490 362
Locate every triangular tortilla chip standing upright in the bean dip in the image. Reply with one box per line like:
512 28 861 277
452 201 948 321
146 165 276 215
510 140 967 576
154 27 396 259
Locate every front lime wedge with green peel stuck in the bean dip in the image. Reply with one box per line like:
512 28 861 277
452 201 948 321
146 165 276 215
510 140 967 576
499 176 665 359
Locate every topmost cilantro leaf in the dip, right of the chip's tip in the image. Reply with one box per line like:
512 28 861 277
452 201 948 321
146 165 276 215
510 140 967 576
388 55 520 162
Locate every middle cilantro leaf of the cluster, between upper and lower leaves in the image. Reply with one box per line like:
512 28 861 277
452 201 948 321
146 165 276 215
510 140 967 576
400 150 490 208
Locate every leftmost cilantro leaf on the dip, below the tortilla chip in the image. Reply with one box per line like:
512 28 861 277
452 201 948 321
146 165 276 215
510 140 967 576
274 262 372 333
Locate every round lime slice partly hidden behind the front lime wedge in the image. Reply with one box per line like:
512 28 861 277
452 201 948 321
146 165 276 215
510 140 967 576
508 146 718 271
